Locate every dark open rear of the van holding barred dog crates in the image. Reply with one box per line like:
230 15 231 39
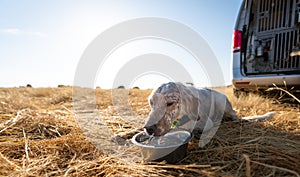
240 0 300 75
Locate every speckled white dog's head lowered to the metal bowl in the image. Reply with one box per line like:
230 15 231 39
144 82 181 136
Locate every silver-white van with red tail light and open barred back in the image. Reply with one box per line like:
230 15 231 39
232 0 300 93
